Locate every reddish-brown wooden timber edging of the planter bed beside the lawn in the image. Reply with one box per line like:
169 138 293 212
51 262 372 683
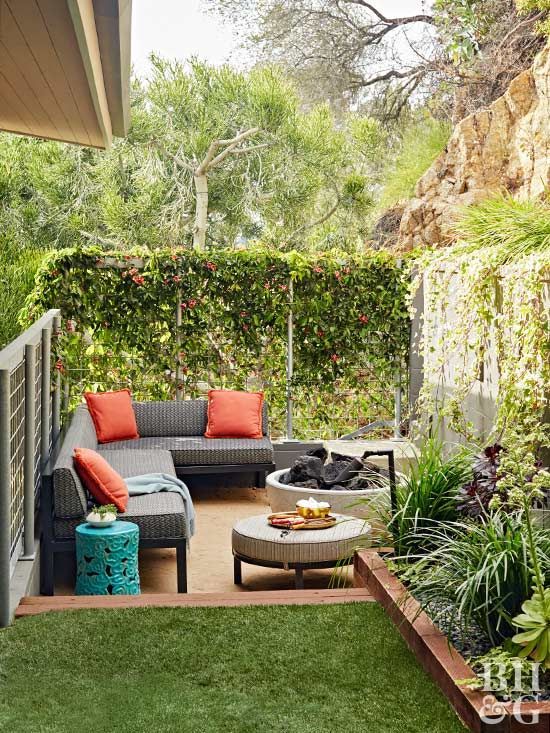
354 550 550 733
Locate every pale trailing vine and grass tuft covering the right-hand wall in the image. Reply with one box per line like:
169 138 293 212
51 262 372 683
412 197 550 449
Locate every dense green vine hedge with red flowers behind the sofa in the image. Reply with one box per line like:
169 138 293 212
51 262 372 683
22 248 409 440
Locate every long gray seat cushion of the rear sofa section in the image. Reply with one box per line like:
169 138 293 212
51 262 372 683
99 436 273 466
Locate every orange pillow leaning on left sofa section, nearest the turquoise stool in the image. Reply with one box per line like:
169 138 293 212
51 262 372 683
74 448 128 512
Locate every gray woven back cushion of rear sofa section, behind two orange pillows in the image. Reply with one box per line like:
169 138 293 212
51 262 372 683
133 400 269 438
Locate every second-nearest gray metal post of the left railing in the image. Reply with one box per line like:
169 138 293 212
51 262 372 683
23 344 36 560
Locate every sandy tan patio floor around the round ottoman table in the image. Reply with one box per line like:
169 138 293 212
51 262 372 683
56 486 350 594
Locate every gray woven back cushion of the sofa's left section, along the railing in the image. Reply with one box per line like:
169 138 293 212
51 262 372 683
53 406 97 519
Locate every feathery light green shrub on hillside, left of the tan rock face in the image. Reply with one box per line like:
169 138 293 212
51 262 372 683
377 117 451 211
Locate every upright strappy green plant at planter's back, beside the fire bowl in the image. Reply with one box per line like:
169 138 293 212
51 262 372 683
388 438 472 557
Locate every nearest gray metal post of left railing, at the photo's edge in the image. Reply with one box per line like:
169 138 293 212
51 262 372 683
0 369 11 627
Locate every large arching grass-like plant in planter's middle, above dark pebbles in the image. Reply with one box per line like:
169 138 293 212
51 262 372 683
408 511 550 644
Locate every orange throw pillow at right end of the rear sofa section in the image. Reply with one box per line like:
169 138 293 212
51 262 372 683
204 389 264 438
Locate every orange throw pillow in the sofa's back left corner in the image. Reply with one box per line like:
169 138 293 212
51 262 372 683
84 389 139 443
